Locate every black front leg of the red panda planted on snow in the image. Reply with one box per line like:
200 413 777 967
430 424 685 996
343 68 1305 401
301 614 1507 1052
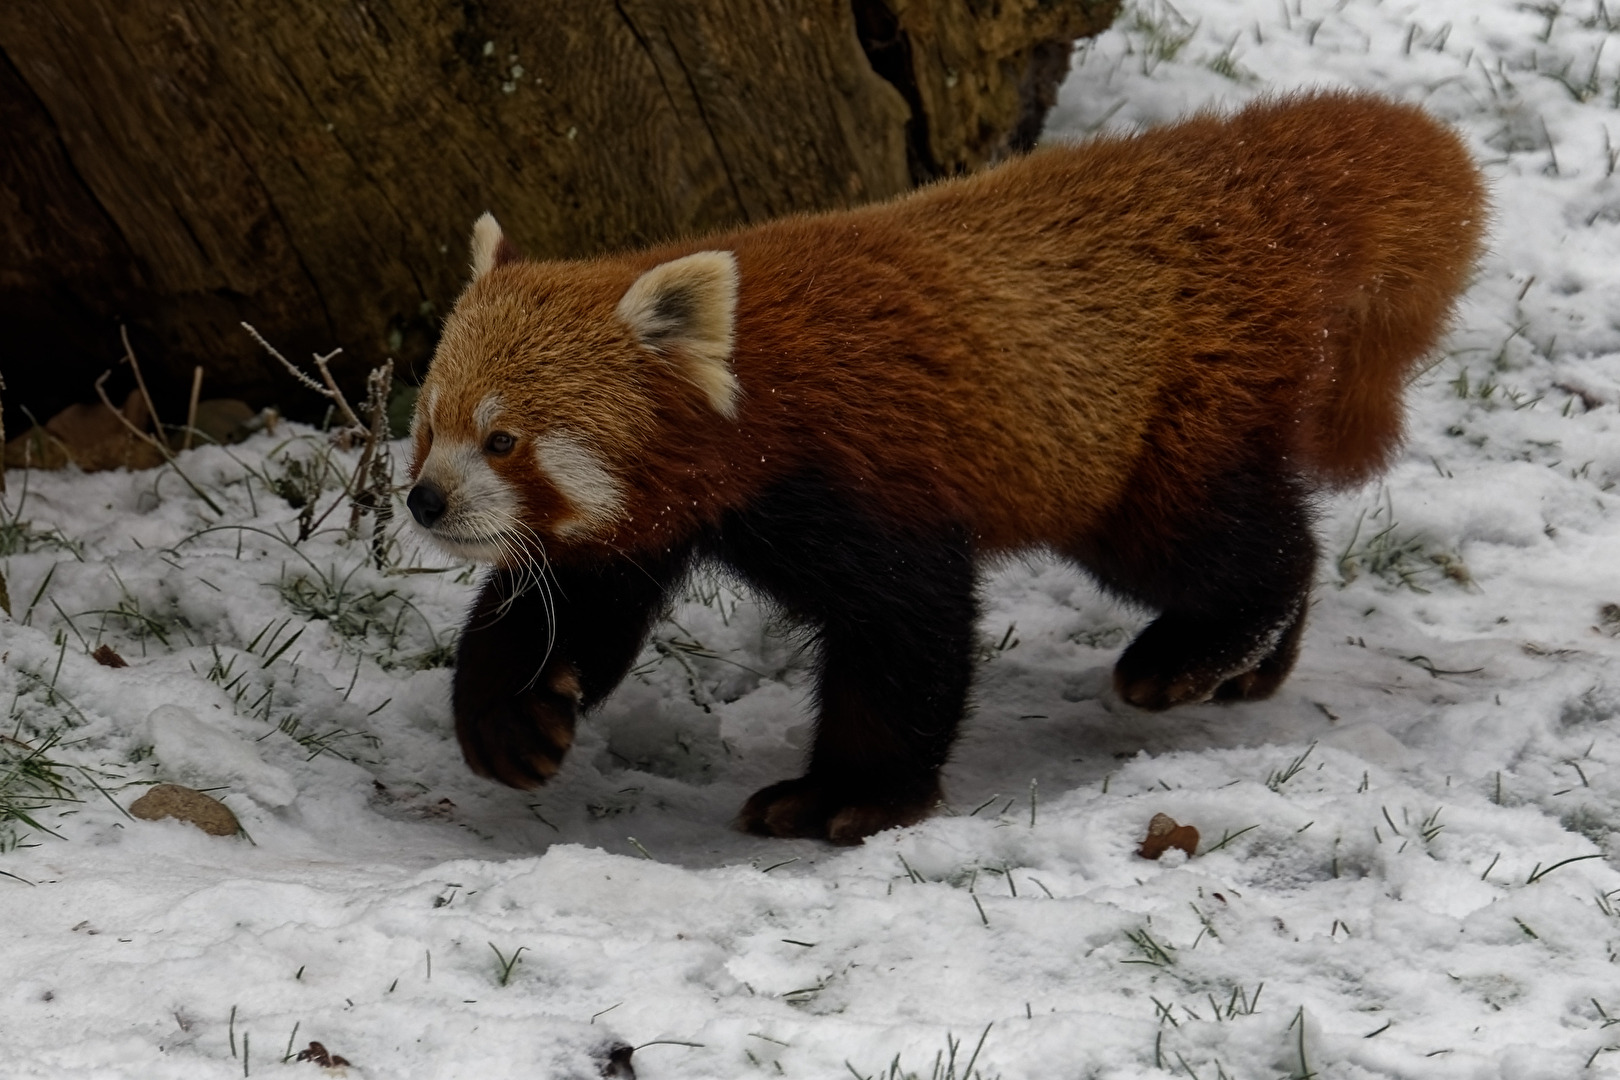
714 474 978 844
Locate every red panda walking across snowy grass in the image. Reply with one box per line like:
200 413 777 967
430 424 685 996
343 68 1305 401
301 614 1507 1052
407 92 1487 844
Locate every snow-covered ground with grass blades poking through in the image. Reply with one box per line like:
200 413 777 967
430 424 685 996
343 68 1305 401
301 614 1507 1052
0 0 1620 1080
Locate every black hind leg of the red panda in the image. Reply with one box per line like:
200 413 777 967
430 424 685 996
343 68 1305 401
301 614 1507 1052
1074 466 1317 709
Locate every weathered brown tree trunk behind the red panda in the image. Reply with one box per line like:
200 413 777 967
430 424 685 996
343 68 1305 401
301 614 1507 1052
0 0 1118 429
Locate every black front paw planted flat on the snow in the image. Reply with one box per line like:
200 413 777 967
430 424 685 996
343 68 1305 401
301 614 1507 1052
737 776 940 844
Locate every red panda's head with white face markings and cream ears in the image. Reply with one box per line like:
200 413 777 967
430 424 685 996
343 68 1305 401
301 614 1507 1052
407 214 740 563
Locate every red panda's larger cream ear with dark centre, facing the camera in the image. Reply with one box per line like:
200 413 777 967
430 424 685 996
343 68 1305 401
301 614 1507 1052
619 251 742 419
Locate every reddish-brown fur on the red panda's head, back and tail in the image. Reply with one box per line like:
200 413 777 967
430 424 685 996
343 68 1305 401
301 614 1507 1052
418 94 1486 554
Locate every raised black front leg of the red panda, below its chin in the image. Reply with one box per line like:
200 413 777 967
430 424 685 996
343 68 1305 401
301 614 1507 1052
450 552 690 789
